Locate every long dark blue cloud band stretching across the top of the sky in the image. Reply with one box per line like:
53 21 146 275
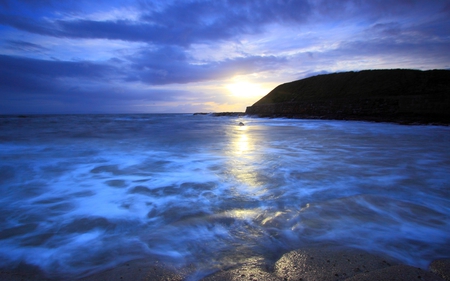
0 0 448 47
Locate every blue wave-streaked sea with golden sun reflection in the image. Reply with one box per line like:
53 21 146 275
0 114 450 279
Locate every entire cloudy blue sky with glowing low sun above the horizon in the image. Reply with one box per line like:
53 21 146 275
0 0 450 114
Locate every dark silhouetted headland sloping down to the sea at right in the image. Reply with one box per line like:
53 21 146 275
246 69 450 125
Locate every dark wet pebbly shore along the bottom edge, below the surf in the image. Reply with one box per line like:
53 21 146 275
0 247 450 281
